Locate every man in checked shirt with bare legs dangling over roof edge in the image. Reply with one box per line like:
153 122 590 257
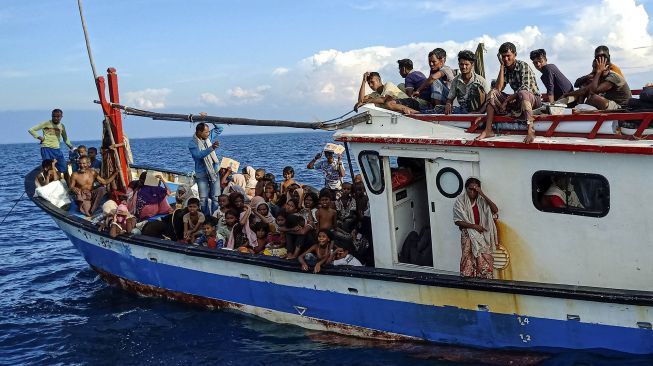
476 42 542 144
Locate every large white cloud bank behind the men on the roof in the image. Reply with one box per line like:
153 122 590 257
268 0 653 108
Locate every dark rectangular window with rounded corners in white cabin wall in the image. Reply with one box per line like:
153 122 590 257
532 171 610 217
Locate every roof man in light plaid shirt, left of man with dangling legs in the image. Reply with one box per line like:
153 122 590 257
444 50 490 114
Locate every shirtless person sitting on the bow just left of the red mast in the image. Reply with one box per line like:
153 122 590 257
69 156 118 216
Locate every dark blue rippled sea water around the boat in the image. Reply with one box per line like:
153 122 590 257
0 132 653 366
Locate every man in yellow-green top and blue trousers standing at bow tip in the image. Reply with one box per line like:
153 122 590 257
28 109 73 180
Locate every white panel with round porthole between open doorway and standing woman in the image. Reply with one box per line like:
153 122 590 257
426 154 478 272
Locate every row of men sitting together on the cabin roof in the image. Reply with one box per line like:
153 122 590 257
354 42 632 143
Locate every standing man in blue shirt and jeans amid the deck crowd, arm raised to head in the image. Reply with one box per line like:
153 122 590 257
188 123 221 215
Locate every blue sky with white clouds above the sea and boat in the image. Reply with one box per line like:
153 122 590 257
0 0 653 143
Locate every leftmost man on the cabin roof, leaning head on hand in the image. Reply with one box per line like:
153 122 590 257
354 72 419 114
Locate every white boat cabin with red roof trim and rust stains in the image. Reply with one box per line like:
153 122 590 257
335 105 653 290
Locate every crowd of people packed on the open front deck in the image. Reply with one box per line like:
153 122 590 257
30 118 373 273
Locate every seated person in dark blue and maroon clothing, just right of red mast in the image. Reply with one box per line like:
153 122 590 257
127 171 173 221
